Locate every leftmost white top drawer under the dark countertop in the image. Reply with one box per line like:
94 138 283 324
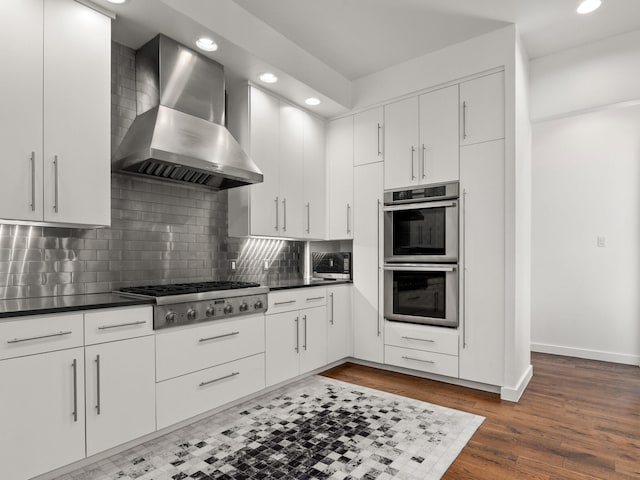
0 313 84 360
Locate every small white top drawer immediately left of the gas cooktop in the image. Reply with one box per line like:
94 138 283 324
84 306 153 345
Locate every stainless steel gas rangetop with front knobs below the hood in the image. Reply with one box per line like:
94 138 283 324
115 282 269 330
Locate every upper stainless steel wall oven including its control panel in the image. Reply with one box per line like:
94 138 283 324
384 182 458 263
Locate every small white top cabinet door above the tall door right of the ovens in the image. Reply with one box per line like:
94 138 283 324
460 72 504 145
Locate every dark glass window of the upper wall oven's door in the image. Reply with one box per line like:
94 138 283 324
393 207 447 256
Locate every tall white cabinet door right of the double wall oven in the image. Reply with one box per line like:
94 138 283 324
460 140 505 385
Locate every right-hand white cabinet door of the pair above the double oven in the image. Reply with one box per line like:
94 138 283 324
418 85 460 183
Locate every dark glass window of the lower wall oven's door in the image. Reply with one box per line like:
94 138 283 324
393 271 447 319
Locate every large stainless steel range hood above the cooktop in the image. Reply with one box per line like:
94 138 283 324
111 35 263 190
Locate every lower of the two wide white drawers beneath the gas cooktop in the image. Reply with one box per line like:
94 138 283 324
156 353 265 429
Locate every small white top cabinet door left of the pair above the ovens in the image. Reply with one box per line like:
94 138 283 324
353 107 384 166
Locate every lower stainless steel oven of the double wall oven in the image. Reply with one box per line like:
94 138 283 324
384 263 458 327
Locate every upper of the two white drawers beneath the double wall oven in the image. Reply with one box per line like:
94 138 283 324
384 321 458 355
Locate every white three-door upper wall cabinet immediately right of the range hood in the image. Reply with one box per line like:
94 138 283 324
229 86 326 238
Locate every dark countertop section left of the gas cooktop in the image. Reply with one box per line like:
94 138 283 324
0 293 155 319
